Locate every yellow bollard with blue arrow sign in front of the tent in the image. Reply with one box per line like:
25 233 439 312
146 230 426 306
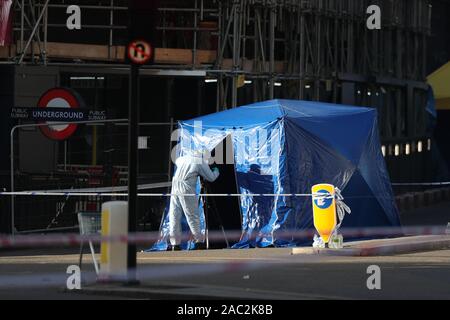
311 184 337 245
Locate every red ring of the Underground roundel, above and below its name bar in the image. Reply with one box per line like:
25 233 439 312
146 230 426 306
38 88 83 140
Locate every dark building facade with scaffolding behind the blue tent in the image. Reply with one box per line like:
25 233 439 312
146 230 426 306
0 0 450 231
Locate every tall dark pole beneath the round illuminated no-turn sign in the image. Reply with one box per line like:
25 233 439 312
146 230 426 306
127 64 139 284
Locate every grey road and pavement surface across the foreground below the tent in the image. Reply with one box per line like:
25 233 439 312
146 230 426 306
0 249 450 300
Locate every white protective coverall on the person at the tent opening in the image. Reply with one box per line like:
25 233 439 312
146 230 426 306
169 156 219 246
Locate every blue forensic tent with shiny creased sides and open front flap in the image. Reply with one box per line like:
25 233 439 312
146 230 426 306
152 100 400 250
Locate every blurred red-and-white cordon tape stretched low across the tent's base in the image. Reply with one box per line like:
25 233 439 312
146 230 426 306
0 226 450 248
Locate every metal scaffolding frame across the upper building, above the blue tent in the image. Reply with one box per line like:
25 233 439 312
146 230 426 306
7 0 431 141
